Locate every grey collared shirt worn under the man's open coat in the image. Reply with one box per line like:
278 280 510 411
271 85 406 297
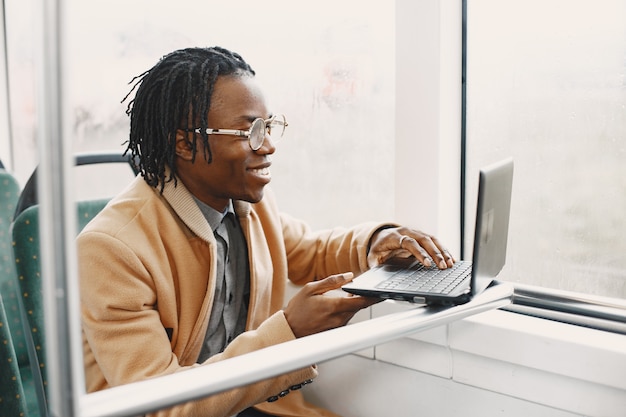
194 197 250 363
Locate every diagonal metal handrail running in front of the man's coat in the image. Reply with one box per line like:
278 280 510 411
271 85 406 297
79 284 513 417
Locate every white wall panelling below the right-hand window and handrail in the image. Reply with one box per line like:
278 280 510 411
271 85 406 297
305 301 626 417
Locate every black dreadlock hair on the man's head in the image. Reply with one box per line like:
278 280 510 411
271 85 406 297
122 47 255 192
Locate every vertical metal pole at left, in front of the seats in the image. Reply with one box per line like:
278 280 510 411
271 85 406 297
34 0 82 417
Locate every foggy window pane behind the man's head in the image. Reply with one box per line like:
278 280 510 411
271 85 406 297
6 0 395 227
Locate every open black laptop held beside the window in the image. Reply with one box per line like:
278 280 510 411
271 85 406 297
342 158 513 305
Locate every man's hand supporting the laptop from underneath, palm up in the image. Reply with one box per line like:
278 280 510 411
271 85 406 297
284 272 381 337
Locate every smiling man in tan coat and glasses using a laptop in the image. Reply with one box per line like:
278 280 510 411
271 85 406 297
78 47 454 417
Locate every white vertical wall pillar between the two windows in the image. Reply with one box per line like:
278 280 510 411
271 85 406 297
395 0 462 255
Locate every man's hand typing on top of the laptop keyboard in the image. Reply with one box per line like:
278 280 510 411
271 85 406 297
367 227 455 269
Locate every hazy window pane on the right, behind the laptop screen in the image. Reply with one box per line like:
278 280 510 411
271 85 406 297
465 0 626 298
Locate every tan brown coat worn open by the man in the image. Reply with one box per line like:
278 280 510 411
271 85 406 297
77 177 380 417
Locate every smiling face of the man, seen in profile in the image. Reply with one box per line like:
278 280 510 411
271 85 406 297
176 76 276 211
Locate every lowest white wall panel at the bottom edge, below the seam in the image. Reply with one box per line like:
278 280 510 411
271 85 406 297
307 352 578 417
